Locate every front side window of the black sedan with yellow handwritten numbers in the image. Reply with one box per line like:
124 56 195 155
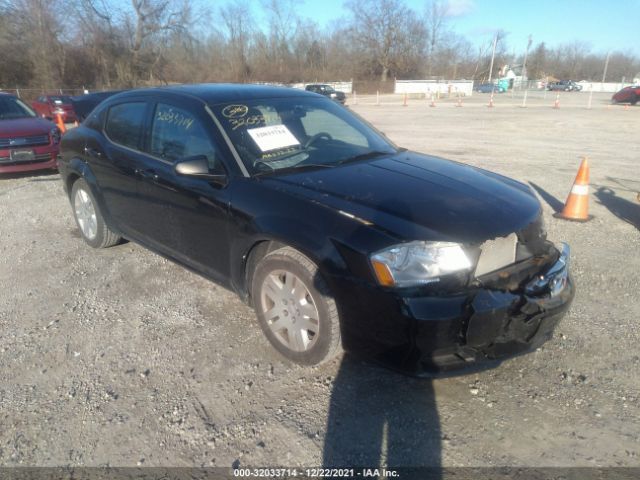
149 103 223 172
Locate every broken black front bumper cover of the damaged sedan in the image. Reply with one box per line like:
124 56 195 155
343 244 575 376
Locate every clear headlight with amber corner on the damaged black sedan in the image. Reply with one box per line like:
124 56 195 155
371 241 472 287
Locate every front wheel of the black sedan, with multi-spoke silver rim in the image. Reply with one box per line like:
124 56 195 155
251 247 342 365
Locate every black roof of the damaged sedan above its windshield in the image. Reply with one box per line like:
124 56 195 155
113 83 315 105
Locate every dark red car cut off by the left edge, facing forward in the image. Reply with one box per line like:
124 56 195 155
0 93 60 174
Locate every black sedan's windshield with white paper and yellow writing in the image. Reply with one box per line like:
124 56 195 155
212 97 397 175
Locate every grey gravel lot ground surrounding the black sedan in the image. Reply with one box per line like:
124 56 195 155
0 93 640 467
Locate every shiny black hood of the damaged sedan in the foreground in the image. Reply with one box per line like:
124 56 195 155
265 152 541 243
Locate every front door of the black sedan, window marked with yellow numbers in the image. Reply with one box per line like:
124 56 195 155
137 100 230 283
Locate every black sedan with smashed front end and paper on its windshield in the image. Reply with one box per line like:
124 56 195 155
59 85 574 374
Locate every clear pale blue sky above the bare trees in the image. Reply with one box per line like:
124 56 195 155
288 0 640 54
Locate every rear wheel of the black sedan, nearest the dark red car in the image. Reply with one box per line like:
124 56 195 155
71 178 121 248
